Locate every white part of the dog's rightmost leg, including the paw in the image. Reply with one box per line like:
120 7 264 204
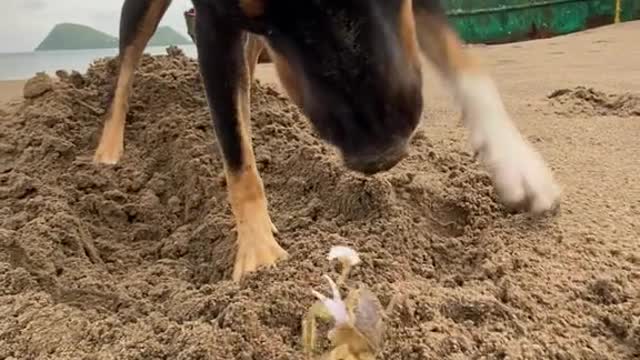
457 75 560 213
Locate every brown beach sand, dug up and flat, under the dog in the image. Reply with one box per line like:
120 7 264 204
0 22 640 359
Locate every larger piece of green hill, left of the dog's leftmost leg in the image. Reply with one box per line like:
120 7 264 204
36 23 118 51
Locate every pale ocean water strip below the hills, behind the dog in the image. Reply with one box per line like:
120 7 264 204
0 45 197 80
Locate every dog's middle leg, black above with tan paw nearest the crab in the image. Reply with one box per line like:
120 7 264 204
196 3 287 281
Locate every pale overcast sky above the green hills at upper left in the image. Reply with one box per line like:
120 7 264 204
0 0 191 52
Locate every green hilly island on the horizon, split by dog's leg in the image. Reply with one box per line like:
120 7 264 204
35 23 192 51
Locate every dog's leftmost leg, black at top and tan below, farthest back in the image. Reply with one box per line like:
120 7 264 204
94 0 171 164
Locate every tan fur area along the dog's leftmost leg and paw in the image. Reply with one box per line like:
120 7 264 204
93 1 168 164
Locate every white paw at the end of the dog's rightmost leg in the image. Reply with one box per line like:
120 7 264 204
472 128 561 214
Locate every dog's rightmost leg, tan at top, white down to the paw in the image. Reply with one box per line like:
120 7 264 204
416 13 560 213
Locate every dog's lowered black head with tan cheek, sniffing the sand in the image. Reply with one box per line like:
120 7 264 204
238 0 422 174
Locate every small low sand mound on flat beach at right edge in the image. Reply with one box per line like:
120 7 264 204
548 86 640 117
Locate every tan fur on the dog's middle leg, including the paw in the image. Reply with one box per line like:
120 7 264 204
225 39 288 281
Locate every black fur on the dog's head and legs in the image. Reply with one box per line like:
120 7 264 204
121 0 442 174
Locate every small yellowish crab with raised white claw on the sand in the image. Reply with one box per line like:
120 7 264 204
302 247 385 360
